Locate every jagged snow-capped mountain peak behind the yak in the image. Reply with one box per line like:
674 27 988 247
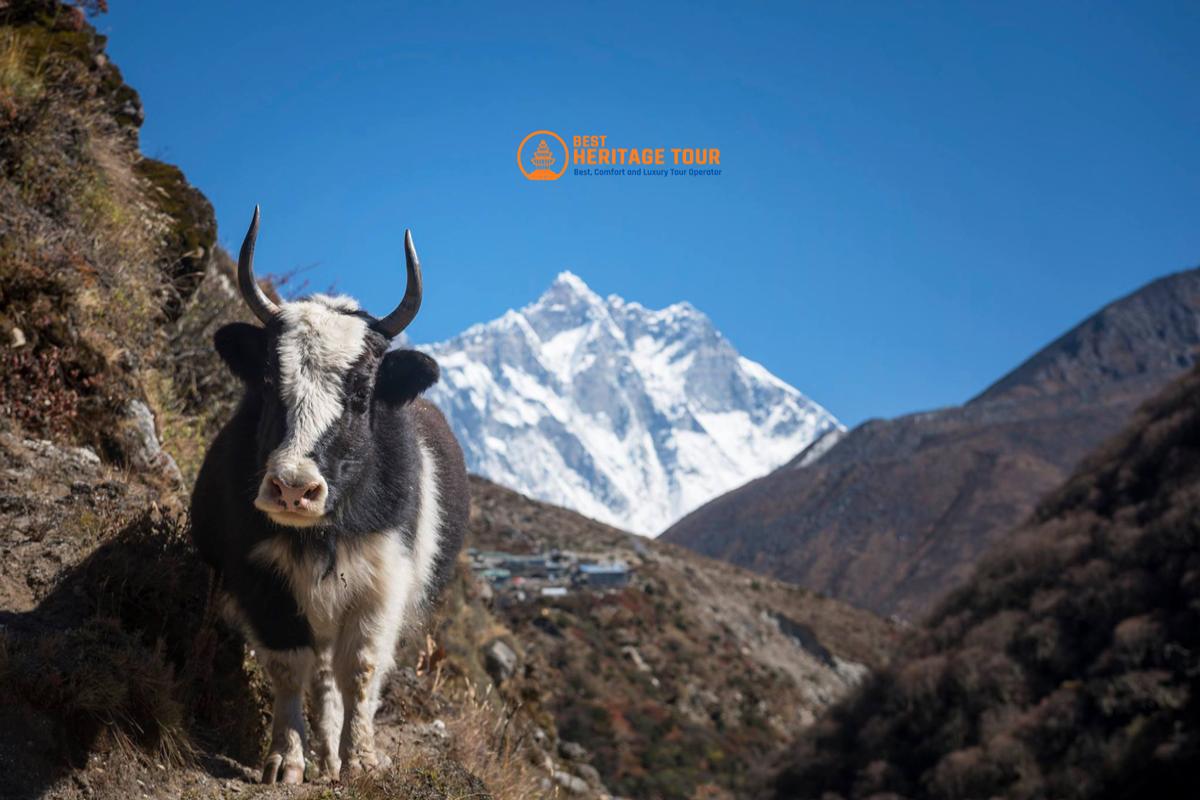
421 272 841 535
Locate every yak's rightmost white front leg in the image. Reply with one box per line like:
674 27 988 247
334 602 403 776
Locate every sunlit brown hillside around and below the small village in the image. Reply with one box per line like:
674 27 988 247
470 479 898 798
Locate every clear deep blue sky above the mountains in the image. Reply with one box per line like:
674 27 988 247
95 0 1200 425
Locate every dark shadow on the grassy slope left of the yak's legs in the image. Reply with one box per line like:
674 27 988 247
0 511 268 798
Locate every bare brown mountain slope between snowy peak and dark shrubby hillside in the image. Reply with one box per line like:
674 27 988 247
664 270 1200 619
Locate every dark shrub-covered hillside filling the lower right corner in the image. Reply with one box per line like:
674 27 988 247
764 362 1200 800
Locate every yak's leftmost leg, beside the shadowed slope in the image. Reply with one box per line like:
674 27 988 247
259 648 313 783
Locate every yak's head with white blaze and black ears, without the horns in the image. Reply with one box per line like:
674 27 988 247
215 295 438 528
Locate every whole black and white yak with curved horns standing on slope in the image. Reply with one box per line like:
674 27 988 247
192 209 468 783
